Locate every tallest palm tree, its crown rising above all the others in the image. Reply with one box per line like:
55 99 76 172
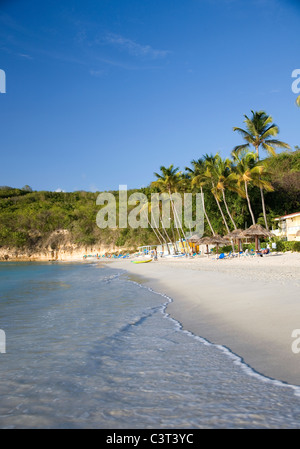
233 111 290 230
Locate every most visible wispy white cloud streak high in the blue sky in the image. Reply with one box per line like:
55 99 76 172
104 33 170 59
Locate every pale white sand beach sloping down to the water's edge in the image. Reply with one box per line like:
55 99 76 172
108 253 300 385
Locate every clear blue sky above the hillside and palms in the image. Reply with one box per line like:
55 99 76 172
0 0 300 191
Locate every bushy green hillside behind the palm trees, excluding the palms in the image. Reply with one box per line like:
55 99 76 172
0 148 300 250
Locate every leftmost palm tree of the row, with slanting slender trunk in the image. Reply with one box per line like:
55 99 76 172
152 164 187 253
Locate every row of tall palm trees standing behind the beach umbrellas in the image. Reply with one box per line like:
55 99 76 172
152 111 300 247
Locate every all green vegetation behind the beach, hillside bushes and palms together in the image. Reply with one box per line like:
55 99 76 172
0 111 300 254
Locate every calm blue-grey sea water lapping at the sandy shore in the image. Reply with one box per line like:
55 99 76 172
0 263 300 429
